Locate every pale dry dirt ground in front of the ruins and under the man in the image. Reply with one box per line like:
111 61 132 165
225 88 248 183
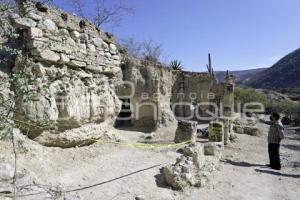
0 122 300 200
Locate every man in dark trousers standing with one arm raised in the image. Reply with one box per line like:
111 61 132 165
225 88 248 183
261 112 284 170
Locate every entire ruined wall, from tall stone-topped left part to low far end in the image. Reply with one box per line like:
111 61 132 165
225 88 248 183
3 1 233 147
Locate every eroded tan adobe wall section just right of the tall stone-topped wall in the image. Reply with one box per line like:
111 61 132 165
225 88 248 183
117 58 176 130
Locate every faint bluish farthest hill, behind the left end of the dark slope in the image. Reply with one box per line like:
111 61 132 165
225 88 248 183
216 68 267 85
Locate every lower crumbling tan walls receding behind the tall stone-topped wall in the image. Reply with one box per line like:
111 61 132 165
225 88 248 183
117 60 234 130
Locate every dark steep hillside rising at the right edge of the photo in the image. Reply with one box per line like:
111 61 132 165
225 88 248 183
245 48 300 89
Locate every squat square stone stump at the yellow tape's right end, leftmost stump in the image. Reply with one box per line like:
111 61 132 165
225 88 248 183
174 121 197 143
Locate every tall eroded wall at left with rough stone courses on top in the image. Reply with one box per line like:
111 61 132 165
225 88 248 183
11 1 122 147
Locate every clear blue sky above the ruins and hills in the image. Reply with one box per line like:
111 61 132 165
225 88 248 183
55 0 300 71
